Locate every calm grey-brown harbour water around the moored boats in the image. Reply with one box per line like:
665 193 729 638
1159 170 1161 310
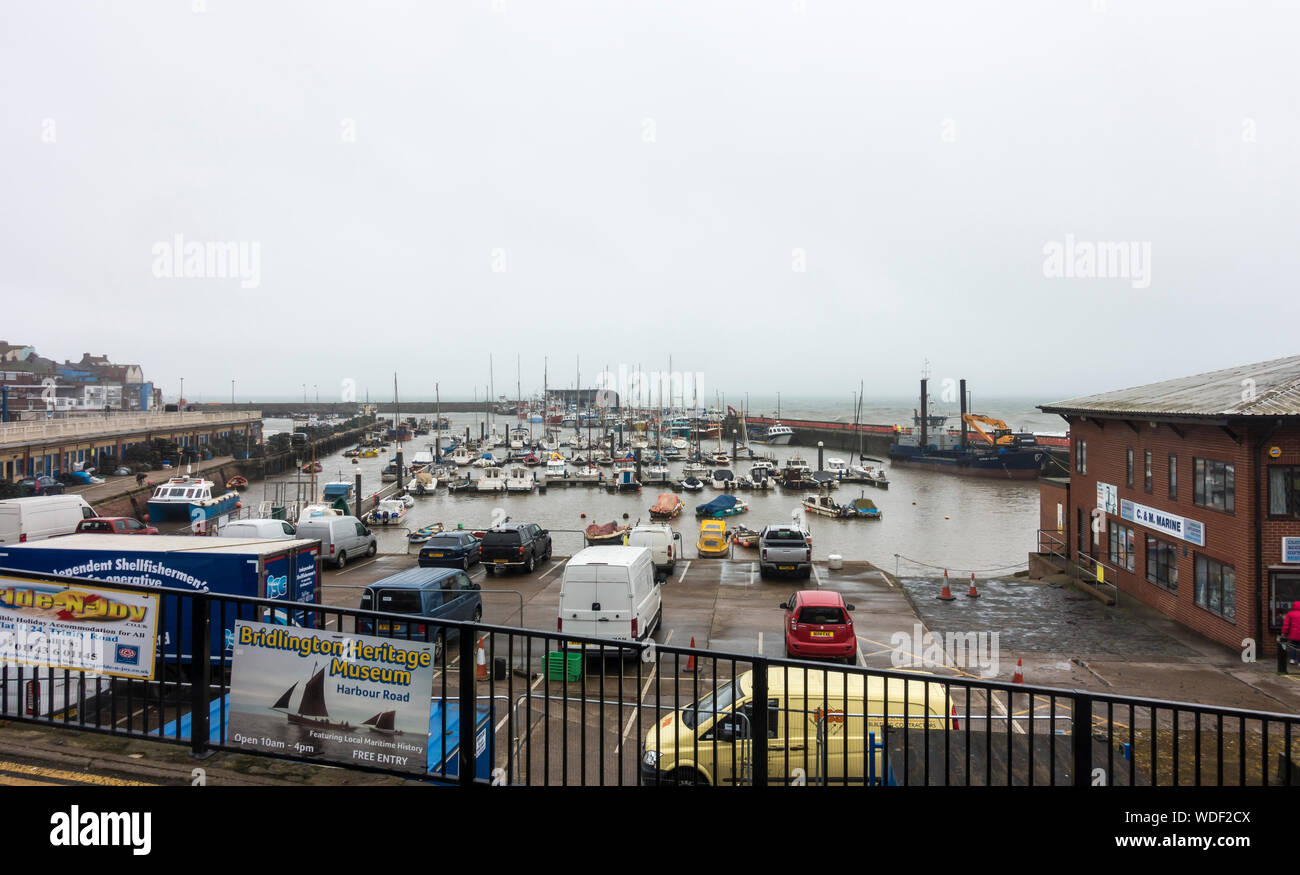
263 400 1045 577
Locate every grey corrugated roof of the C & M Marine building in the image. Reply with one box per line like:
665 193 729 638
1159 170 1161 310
1039 355 1300 417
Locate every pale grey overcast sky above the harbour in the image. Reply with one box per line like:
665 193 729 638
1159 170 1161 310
0 0 1300 400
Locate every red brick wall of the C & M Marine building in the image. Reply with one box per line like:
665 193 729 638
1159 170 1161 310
1053 419 1300 655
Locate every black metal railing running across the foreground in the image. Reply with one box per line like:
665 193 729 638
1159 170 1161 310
0 572 1300 787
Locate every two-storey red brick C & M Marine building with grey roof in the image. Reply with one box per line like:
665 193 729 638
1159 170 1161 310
1040 356 1300 655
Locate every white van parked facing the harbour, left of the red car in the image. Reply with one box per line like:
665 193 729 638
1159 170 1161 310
556 547 663 650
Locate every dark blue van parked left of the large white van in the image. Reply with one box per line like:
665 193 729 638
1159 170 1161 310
356 568 484 663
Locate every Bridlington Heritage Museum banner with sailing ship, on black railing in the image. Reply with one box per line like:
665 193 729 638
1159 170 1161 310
228 620 433 774
